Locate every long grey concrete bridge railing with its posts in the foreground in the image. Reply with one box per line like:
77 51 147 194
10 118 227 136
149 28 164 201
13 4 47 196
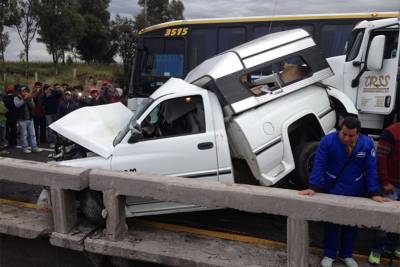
0 159 400 267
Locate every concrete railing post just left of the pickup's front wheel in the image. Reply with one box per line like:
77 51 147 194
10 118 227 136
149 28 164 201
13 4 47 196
51 188 77 234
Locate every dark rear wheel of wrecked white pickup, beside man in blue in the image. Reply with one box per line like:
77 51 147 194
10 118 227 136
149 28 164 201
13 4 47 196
294 142 319 189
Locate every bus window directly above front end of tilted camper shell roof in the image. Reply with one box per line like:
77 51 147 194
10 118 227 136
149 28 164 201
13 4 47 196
218 27 246 52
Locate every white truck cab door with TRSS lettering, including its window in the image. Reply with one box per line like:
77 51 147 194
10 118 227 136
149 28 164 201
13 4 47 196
356 26 399 115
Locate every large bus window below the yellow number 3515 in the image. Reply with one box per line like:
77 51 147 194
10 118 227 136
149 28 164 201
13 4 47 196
135 37 185 95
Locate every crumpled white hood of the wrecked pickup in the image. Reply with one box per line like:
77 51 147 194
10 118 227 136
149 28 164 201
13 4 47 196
49 103 133 158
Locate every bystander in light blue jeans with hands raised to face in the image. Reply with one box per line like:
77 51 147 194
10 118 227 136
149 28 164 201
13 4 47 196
14 87 42 153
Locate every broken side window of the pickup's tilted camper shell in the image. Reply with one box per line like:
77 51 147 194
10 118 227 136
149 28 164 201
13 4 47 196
240 56 311 95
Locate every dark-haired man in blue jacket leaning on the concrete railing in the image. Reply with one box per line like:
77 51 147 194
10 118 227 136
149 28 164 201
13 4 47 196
299 117 387 267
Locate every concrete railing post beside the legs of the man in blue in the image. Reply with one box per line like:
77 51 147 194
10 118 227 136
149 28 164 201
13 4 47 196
287 217 309 267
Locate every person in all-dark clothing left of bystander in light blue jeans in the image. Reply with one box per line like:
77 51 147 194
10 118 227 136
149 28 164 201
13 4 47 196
3 85 17 147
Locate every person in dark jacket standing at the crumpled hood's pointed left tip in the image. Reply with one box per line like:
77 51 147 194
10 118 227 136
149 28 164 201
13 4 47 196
42 84 63 148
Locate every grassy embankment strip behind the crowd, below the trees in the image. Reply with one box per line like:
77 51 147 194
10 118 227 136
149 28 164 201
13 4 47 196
0 62 123 87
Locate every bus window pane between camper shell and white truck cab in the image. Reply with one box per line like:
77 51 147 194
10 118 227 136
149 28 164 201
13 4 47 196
320 24 353 58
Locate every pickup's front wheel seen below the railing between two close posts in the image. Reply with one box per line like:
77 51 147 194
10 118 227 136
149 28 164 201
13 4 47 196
79 189 105 225
